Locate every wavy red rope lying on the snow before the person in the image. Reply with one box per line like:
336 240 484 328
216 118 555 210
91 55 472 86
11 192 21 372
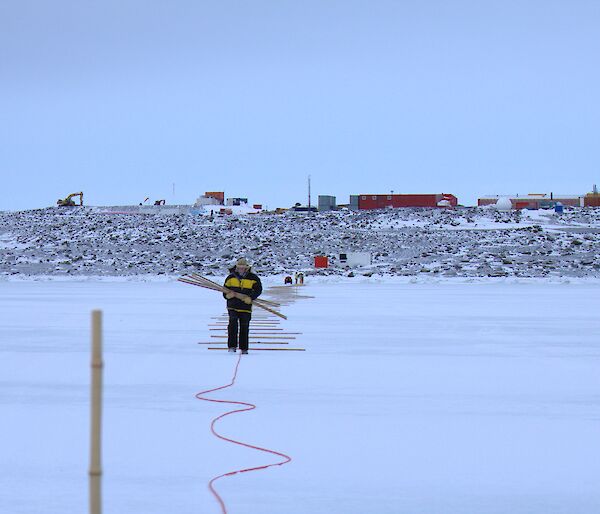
196 354 292 514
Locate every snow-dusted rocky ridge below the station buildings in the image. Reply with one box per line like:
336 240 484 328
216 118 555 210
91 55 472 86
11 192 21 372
0 207 600 277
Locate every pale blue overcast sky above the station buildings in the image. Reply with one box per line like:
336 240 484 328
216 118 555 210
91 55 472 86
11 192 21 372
0 0 600 210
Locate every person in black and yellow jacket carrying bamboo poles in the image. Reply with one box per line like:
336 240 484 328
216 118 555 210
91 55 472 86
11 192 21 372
223 258 262 353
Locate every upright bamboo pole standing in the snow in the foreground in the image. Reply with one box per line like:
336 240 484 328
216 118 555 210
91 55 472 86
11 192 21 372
89 310 104 514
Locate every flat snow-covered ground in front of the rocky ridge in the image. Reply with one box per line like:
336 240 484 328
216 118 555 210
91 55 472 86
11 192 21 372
0 277 600 514
